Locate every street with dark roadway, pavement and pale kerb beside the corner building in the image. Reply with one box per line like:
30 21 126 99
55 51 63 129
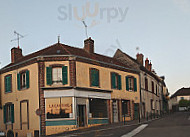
50 112 190 137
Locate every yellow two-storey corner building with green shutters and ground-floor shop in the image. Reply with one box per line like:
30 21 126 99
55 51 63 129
0 38 141 137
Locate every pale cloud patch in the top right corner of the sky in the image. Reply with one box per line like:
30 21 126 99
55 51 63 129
173 0 190 13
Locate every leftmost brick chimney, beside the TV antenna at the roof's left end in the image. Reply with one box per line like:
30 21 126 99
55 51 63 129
11 46 23 63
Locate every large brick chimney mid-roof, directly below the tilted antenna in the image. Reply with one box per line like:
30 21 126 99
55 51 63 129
84 37 94 53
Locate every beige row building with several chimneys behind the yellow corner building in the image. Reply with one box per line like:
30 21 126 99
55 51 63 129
114 49 169 118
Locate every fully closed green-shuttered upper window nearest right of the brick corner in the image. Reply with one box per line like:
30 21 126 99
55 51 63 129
90 68 100 87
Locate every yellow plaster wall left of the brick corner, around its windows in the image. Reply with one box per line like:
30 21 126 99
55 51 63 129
0 63 39 136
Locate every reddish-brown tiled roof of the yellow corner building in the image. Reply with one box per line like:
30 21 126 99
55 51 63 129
3 43 137 69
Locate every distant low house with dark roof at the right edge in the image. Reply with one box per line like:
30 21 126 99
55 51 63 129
169 87 190 111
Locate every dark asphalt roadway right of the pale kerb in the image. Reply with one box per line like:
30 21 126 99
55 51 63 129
134 112 190 137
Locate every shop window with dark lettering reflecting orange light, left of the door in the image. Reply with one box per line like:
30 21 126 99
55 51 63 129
46 97 73 119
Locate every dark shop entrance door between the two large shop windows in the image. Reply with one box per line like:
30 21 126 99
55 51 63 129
78 105 86 127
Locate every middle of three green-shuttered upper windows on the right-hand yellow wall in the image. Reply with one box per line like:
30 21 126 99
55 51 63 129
111 72 121 90
